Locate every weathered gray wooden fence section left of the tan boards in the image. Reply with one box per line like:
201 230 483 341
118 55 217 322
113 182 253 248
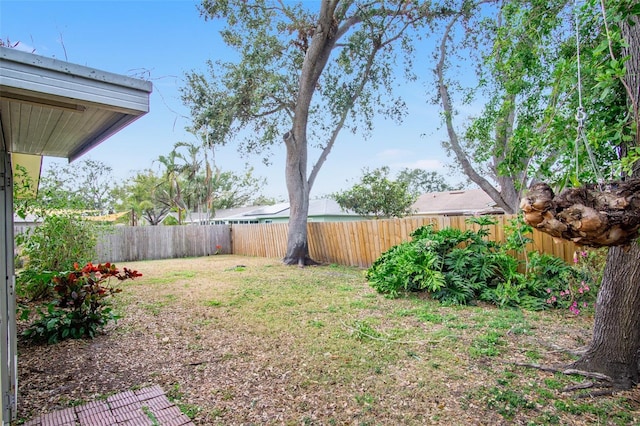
97 225 231 262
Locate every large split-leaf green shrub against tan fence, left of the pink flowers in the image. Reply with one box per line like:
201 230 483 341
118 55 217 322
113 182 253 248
366 218 521 305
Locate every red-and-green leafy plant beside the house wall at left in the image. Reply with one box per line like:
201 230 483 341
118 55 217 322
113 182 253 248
22 263 142 343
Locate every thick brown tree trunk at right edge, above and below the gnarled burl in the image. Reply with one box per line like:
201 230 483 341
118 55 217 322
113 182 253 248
573 11 640 389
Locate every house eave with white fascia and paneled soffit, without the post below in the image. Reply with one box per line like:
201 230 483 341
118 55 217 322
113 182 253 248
0 47 152 160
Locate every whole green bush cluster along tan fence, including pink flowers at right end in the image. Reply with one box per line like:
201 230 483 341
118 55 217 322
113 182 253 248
366 217 597 310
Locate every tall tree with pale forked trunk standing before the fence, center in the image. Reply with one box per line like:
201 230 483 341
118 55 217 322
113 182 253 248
183 0 448 265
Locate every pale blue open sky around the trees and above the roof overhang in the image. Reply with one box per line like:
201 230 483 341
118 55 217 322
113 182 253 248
0 0 461 199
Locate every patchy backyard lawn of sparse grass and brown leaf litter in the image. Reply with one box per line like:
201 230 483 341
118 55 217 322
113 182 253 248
18 256 640 425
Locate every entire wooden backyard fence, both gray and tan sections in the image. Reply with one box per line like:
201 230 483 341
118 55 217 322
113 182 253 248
92 216 577 267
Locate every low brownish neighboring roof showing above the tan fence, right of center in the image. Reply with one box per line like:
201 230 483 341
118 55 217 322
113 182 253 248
413 189 504 216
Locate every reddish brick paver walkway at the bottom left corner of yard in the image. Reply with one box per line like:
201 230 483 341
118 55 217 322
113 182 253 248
24 385 193 426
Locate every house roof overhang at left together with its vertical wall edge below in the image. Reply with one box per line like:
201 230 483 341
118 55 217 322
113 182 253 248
0 47 152 425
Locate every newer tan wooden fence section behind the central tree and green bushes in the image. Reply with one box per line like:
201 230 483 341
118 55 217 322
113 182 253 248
222 215 577 268
